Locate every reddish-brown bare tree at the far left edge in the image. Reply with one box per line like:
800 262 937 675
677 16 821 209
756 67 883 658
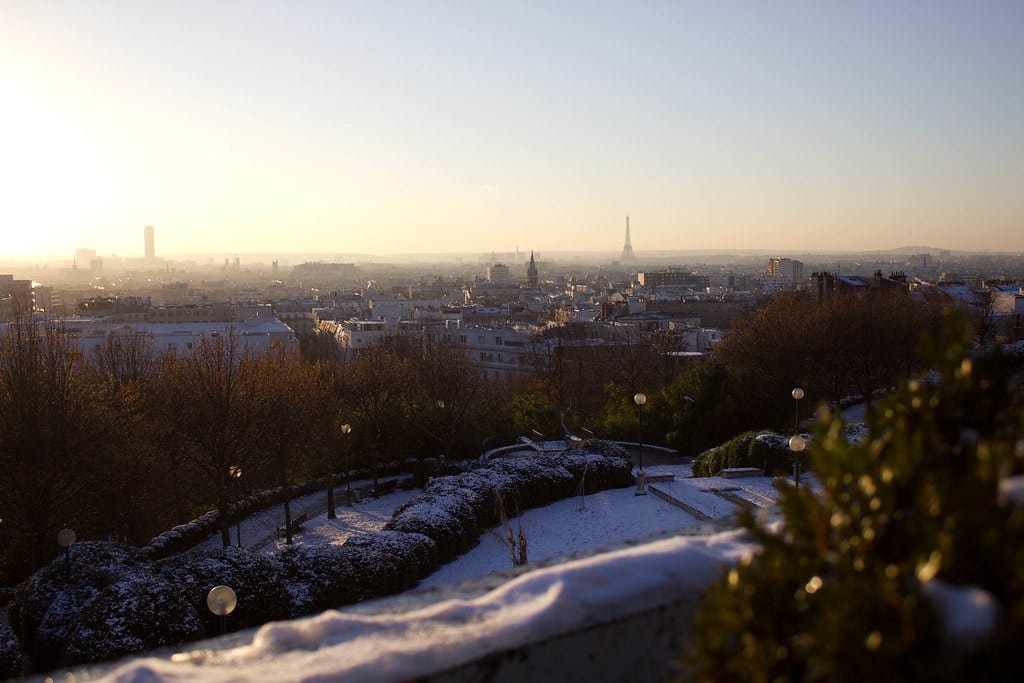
0 317 120 574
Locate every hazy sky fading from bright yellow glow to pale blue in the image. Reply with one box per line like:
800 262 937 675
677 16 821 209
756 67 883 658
0 0 1024 256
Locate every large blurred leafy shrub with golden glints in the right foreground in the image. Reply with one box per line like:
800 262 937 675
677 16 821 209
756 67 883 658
687 317 1024 681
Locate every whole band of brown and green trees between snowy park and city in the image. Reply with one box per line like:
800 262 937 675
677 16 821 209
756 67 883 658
0 293 941 585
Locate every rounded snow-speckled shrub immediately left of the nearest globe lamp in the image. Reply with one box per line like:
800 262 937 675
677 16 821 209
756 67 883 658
62 572 204 666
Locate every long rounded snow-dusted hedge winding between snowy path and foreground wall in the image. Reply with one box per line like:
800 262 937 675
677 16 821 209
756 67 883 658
8 446 633 670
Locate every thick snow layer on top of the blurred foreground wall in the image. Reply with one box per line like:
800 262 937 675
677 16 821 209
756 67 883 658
98 531 754 683
